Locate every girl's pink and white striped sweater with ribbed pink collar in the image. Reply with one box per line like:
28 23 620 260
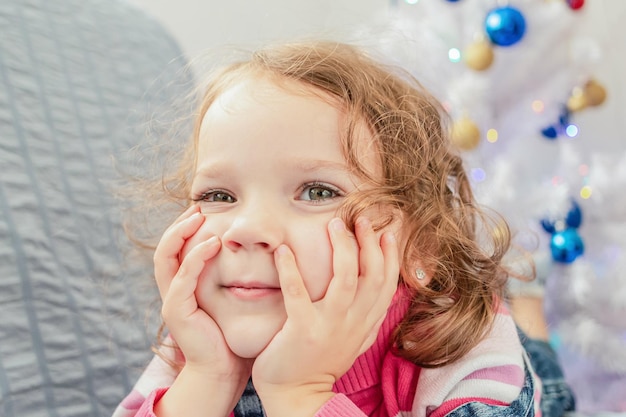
113 292 541 417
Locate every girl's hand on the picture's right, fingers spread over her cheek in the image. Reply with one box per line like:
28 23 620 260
252 217 399 417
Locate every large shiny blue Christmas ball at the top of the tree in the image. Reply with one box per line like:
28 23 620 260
485 6 526 46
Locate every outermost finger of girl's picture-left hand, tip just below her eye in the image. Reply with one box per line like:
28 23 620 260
153 212 204 298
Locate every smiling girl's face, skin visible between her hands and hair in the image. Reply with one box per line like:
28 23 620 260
182 79 381 358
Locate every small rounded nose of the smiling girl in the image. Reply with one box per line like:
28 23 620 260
222 204 283 252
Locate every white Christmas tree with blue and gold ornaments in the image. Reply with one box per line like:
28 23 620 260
364 0 626 412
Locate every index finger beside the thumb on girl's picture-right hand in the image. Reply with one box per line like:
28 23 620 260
324 218 359 313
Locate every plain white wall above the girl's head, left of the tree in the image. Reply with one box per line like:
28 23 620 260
128 0 389 56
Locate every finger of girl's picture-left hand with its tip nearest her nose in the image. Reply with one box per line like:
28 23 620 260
162 236 221 325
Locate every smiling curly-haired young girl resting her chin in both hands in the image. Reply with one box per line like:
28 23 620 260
115 42 571 417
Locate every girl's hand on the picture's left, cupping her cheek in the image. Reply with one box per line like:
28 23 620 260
154 205 252 382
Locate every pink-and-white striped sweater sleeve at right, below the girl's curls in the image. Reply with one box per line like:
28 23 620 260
412 308 540 417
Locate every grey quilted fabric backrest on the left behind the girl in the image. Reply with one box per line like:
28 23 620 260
0 0 190 417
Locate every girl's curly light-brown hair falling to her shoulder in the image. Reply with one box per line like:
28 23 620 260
127 42 511 367
